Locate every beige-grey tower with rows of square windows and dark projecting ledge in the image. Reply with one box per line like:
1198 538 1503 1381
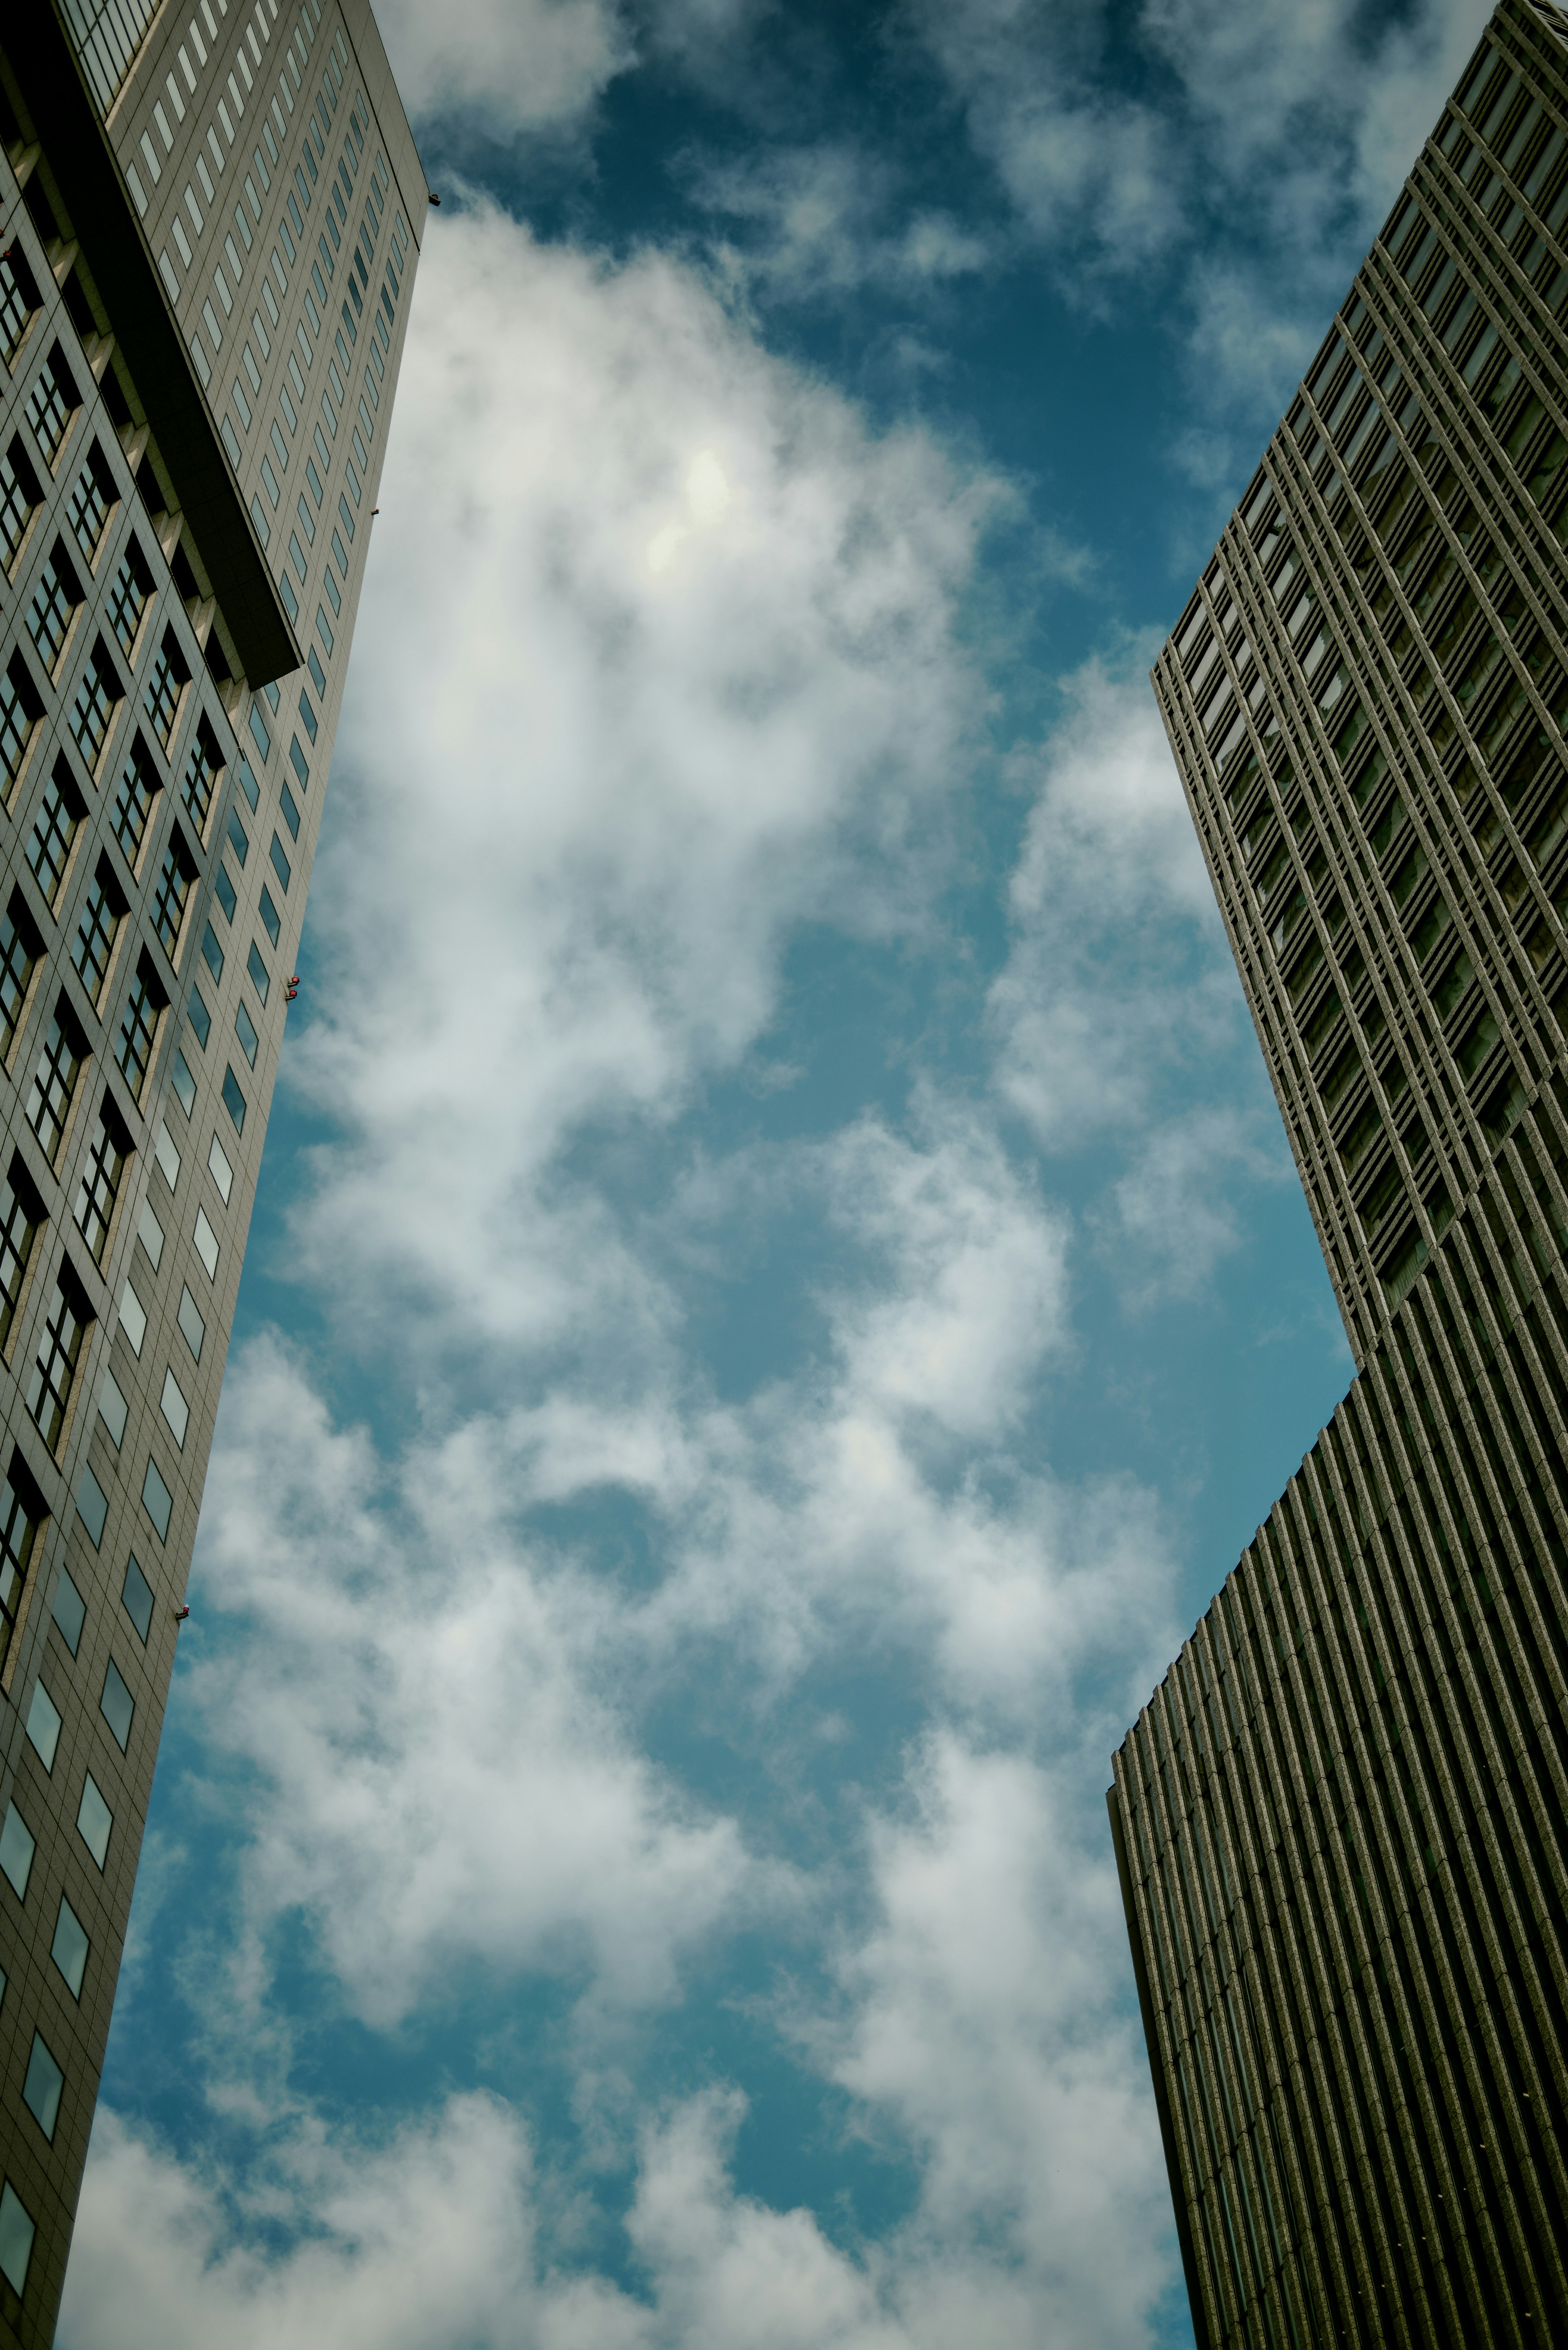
0 0 428 2345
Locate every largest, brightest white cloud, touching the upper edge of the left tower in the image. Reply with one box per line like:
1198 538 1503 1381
287 212 992 1353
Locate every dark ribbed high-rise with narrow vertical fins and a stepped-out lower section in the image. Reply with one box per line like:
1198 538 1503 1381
1109 0 1568 2350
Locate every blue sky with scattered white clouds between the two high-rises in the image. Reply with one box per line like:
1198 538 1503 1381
59 0 1486 2350
